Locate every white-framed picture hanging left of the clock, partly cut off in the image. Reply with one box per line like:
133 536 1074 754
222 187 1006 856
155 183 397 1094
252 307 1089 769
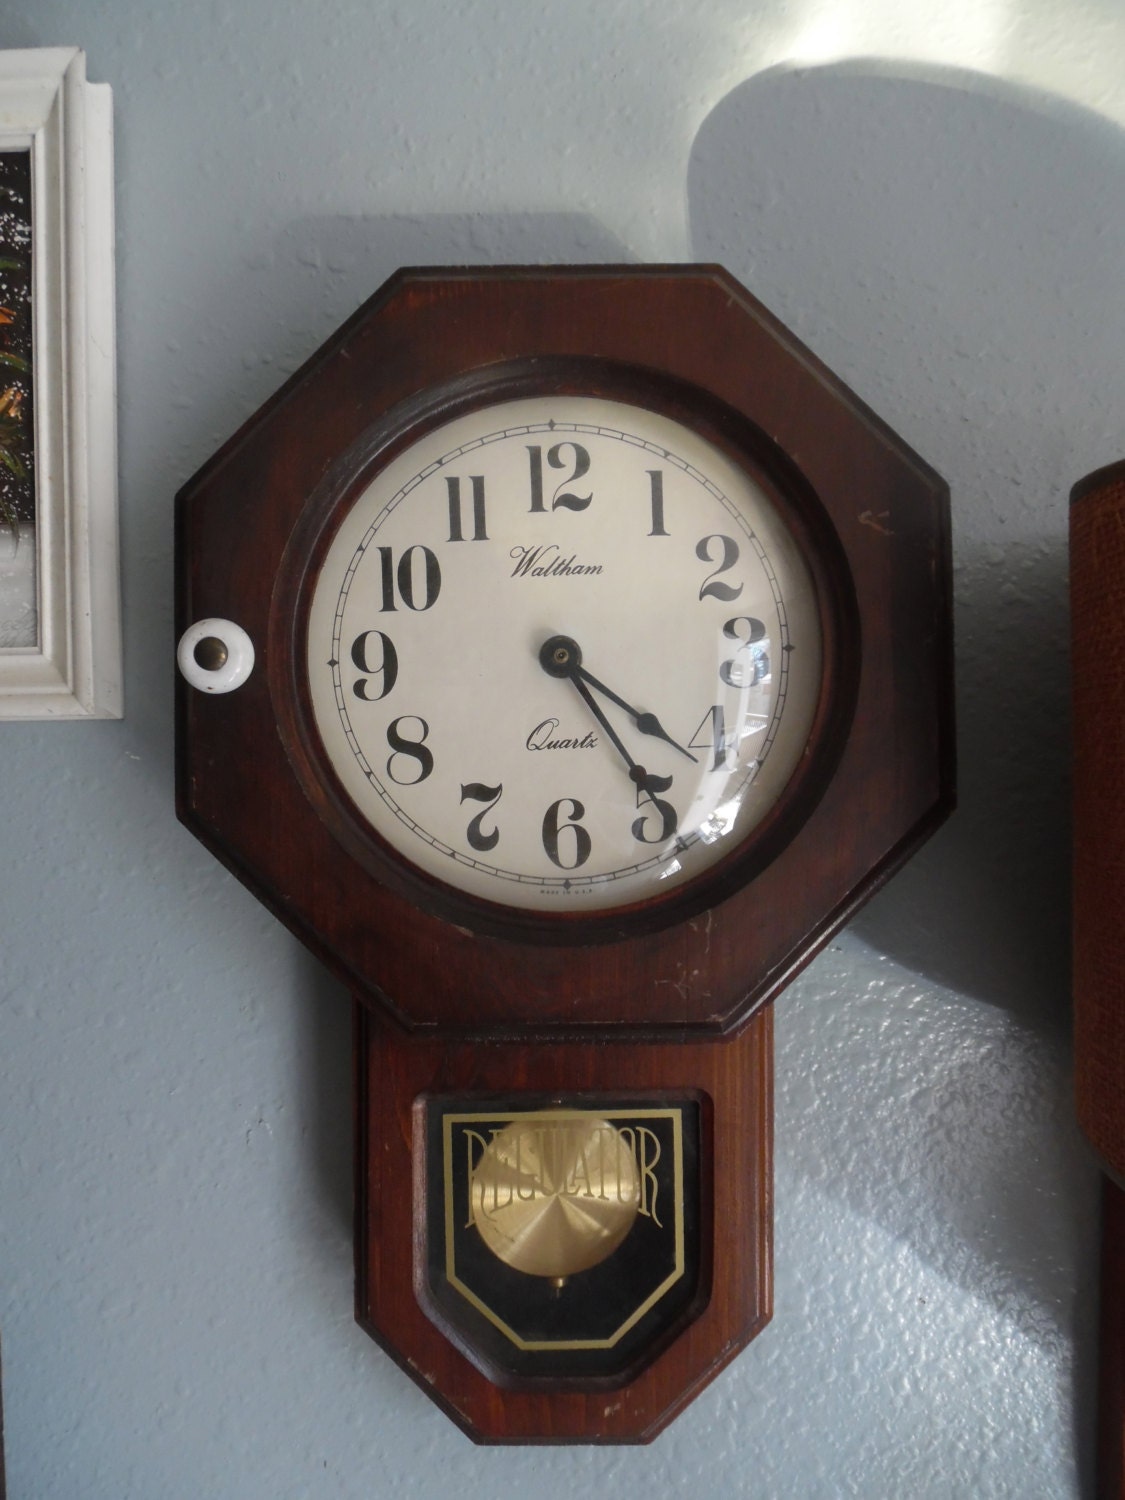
0 48 122 719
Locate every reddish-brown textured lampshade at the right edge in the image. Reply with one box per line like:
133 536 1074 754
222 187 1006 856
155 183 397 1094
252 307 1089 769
1071 462 1125 1179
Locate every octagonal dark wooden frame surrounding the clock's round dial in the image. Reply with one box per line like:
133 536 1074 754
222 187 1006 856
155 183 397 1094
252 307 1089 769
177 266 953 1038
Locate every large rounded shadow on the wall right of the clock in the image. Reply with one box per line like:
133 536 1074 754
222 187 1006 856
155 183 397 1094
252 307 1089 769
689 65 1125 1031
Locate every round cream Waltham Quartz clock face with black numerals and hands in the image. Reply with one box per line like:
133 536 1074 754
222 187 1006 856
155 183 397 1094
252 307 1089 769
306 396 822 912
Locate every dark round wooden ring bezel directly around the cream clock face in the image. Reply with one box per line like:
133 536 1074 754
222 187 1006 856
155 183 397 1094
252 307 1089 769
269 356 861 947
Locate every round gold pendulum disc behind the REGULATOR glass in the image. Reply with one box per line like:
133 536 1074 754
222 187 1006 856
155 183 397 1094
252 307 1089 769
471 1112 641 1283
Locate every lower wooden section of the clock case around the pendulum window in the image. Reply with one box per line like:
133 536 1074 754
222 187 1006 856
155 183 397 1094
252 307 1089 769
354 999 773 1443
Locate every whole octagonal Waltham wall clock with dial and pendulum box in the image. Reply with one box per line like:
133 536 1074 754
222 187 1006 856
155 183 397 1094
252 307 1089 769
177 266 953 1442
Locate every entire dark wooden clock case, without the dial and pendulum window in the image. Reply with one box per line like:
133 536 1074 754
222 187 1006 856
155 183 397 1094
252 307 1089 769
177 266 953 1442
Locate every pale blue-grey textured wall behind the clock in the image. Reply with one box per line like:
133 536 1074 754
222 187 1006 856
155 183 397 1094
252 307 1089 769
0 0 1125 1500
